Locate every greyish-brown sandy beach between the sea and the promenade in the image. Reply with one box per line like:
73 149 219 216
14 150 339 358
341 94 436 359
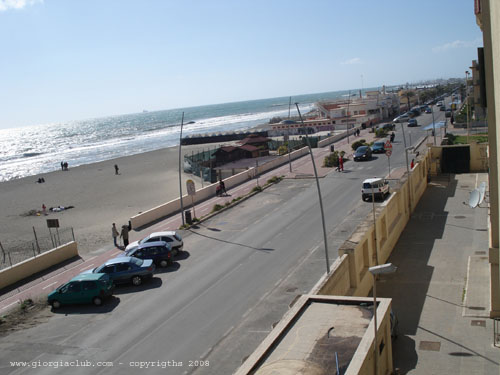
0 144 229 256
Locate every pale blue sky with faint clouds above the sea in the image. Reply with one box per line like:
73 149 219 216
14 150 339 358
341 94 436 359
0 0 482 128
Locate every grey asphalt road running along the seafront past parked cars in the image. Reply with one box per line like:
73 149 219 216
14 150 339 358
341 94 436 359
0 103 444 374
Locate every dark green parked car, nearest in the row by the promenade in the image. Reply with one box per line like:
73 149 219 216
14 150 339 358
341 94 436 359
47 273 114 309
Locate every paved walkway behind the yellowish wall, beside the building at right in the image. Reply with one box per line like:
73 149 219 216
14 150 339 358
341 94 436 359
377 174 500 375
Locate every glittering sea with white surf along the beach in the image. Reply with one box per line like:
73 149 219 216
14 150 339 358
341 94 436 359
0 90 368 182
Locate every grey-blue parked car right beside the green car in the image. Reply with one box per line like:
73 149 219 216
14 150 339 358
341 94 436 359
84 256 156 286
